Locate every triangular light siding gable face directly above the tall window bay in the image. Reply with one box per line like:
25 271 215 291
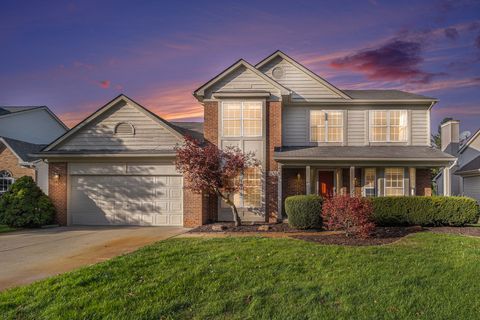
205 66 280 99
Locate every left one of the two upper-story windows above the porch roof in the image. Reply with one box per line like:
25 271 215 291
310 110 343 142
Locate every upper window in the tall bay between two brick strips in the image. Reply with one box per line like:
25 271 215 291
222 101 263 137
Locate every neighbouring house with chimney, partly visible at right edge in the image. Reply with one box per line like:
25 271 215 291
434 120 480 201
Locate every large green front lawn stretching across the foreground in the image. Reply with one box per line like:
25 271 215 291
0 233 480 319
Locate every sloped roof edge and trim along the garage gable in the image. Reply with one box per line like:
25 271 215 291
42 94 185 152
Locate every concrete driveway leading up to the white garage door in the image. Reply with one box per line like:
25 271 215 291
0 227 188 290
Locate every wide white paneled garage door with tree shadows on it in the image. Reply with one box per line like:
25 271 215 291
68 167 183 226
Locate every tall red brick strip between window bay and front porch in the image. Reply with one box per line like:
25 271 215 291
265 101 282 222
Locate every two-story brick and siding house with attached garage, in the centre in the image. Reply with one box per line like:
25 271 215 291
40 51 455 227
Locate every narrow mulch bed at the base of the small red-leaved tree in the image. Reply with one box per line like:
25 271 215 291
189 222 322 233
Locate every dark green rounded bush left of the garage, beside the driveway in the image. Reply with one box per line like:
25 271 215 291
0 176 55 228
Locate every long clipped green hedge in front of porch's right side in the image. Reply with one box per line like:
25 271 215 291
372 196 479 226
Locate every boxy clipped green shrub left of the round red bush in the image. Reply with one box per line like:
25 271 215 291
285 195 323 229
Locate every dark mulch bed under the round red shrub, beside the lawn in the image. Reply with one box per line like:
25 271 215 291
292 227 422 246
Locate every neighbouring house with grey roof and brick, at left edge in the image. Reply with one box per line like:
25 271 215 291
0 106 68 195
